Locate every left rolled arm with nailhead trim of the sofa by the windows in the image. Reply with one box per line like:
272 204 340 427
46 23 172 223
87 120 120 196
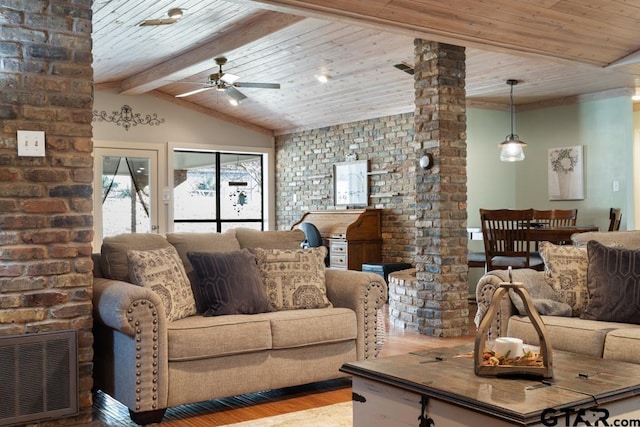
93 278 169 418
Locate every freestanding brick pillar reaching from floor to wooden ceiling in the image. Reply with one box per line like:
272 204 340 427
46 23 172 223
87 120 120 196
414 40 469 337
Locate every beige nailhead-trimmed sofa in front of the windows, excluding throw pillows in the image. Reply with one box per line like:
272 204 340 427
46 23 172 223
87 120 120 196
93 229 387 424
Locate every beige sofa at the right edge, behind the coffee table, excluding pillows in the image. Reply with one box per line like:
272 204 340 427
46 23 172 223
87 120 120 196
475 231 640 364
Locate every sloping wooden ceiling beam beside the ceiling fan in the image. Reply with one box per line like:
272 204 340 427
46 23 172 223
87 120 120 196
120 10 305 95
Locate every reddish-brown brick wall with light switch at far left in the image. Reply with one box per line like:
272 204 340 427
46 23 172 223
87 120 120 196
0 0 93 425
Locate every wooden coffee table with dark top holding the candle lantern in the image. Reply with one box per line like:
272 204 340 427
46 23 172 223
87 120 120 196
341 345 640 427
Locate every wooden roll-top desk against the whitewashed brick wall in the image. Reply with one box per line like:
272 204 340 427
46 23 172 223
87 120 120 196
291 209 382 270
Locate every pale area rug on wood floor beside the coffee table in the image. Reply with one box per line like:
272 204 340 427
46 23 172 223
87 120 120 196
223 402 353 427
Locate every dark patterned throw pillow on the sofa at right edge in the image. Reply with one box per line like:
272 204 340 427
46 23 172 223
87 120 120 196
582 241 640 324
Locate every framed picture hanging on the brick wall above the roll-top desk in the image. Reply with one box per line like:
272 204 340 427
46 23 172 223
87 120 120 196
333 160 369 206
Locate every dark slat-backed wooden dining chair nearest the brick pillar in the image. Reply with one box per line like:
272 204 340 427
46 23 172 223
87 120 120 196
480 209 544 271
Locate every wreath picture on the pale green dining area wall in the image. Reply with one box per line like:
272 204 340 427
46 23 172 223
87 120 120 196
548 145 584 200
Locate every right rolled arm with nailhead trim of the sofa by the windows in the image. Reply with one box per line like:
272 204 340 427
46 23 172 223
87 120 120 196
325 269 387 360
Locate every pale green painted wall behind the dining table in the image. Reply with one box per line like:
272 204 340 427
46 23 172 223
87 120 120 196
467 96 640 234
